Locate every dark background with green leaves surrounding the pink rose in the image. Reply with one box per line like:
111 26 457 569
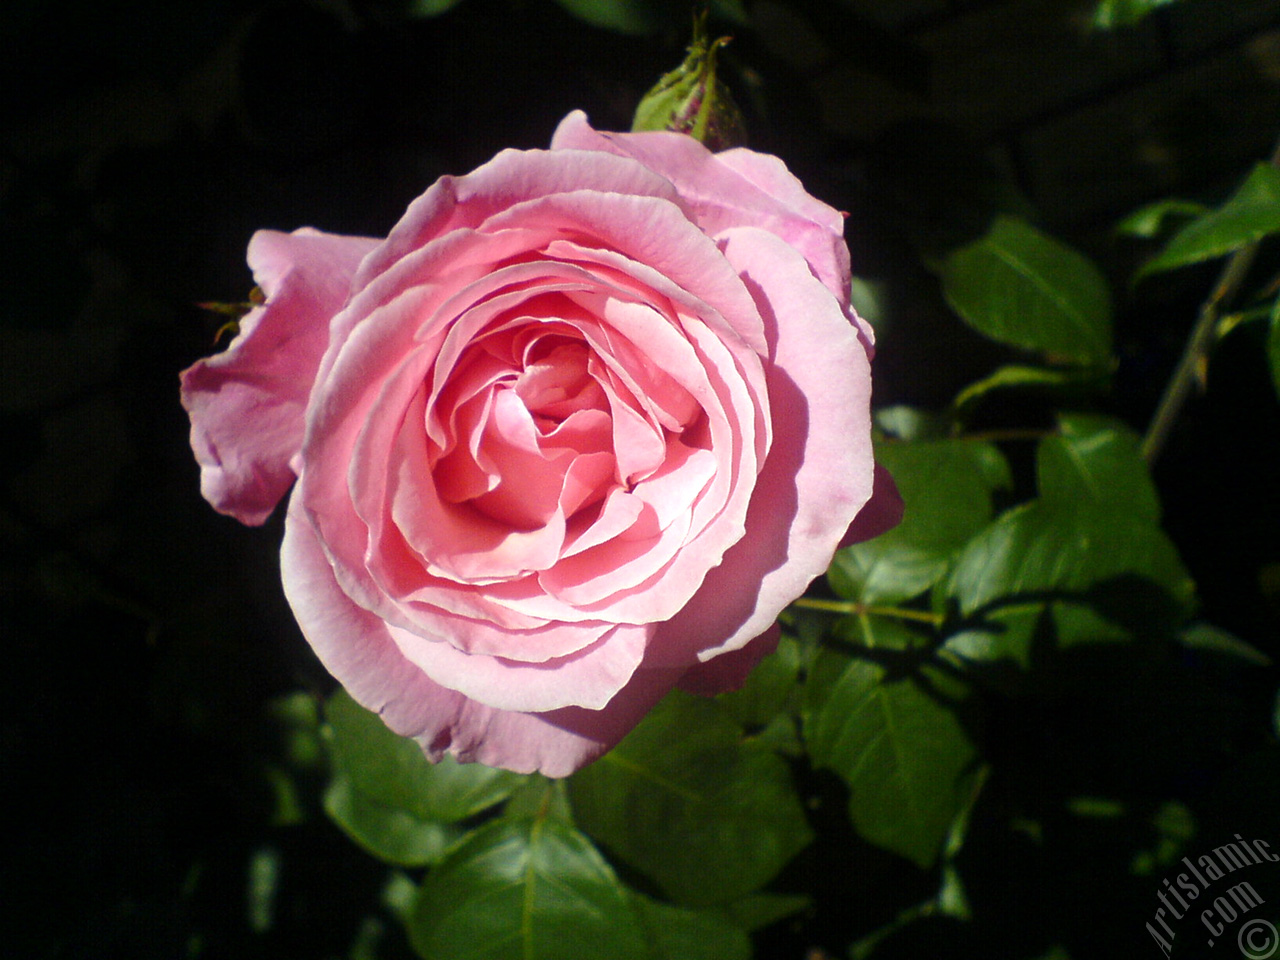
0 0 1280 960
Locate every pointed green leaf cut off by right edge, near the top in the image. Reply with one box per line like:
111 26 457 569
1138 164 1280 276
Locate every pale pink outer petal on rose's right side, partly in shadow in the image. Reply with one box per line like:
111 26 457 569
654 228 874 662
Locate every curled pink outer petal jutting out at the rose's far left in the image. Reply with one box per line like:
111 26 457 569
182 228 378 525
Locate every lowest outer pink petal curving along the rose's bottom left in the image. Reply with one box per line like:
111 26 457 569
280 491 681 777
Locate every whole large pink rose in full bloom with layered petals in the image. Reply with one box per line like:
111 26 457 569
183 113 900 776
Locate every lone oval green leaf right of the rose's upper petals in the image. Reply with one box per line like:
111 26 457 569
940 216 1111 366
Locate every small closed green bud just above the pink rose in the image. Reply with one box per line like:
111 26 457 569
631 8 746 150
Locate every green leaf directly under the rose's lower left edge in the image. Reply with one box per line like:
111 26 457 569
325 690 524 823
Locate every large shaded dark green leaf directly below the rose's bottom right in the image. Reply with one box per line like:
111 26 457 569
570 691 810 905
